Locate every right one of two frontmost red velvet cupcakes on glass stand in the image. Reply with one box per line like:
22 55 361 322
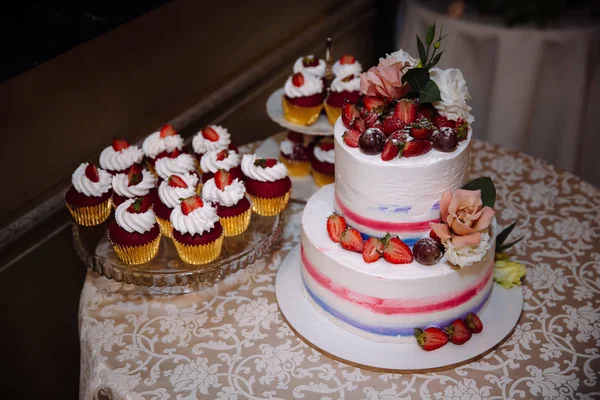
171 195 224 265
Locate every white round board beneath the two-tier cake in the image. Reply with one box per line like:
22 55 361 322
275 245 523 372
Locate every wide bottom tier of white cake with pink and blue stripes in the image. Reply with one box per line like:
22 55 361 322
301 185 495 343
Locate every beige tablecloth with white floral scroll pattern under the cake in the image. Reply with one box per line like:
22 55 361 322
79 141 600 400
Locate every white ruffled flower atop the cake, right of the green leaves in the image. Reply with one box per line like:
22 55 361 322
430 67 475 124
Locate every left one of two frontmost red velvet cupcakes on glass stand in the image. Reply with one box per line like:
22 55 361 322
108 196 160 264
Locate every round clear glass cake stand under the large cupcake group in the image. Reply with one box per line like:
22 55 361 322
73 214 284 294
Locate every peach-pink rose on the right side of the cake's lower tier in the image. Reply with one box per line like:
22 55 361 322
430 189 496 247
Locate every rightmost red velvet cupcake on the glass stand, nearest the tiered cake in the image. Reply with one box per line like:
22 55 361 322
242 154 292 216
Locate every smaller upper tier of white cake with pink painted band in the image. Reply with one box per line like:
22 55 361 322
334 118 471 246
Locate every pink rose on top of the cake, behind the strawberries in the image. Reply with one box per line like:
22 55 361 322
360 60 410 100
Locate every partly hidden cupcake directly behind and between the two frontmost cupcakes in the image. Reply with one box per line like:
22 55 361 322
153 174 198 237
